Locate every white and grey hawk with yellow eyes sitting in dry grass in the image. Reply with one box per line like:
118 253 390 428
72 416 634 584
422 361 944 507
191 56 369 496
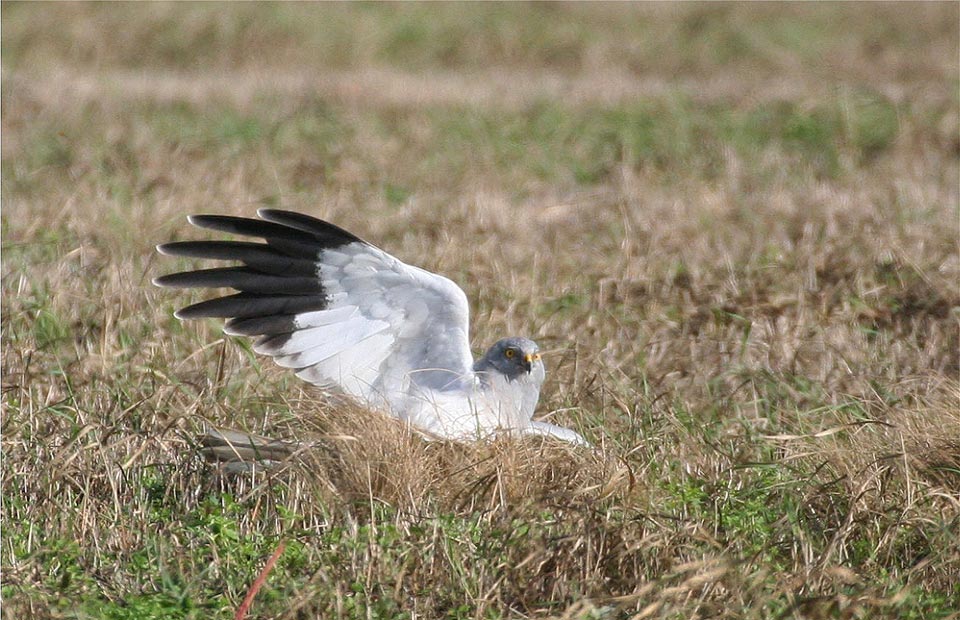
154 209 587 445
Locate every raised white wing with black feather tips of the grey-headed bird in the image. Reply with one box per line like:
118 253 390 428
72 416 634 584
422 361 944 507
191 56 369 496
154 209 473 414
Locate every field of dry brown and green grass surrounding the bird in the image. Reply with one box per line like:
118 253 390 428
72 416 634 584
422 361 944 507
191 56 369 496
0 2 960 619
